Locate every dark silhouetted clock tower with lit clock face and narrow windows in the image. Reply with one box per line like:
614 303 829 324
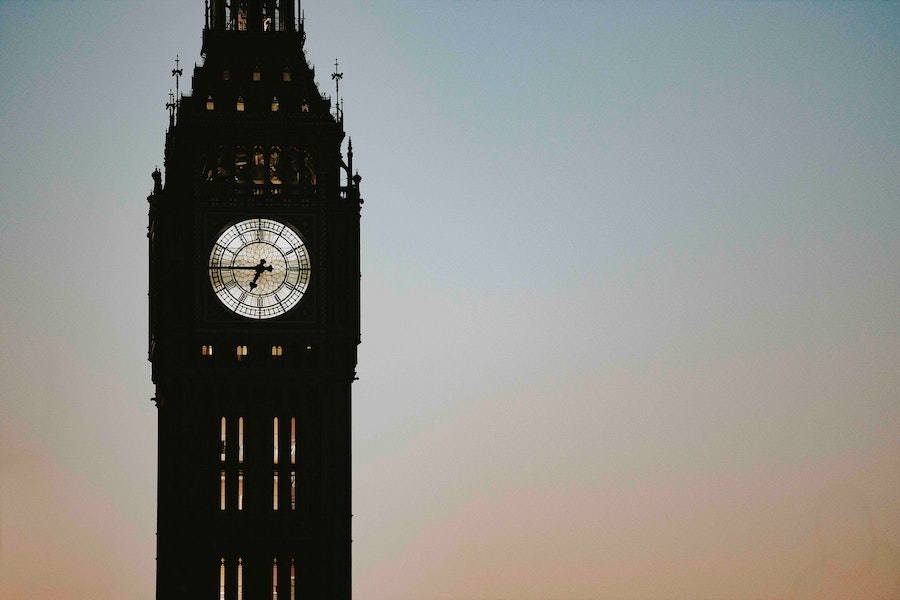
148 0 362 600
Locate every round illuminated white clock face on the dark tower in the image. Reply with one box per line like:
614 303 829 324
209 218 310 319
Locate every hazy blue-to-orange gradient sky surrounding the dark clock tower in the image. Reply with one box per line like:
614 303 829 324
0 0 900 600
